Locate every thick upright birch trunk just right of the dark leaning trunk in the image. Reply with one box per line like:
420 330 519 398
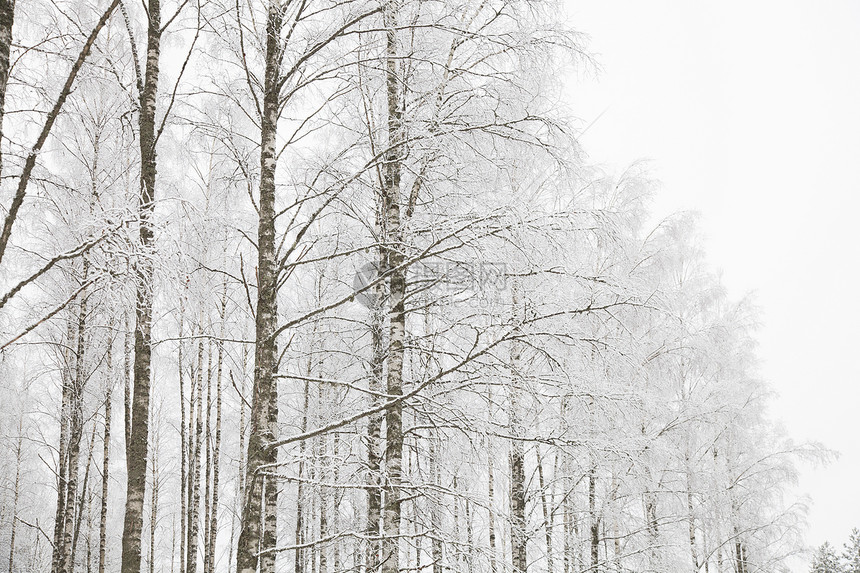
122 0 162 573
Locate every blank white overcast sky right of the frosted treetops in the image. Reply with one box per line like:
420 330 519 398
567 0 860 571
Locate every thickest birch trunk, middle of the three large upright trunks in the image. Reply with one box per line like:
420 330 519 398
236 0 283 573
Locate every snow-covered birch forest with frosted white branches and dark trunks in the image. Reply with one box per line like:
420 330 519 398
0 0 820 573
